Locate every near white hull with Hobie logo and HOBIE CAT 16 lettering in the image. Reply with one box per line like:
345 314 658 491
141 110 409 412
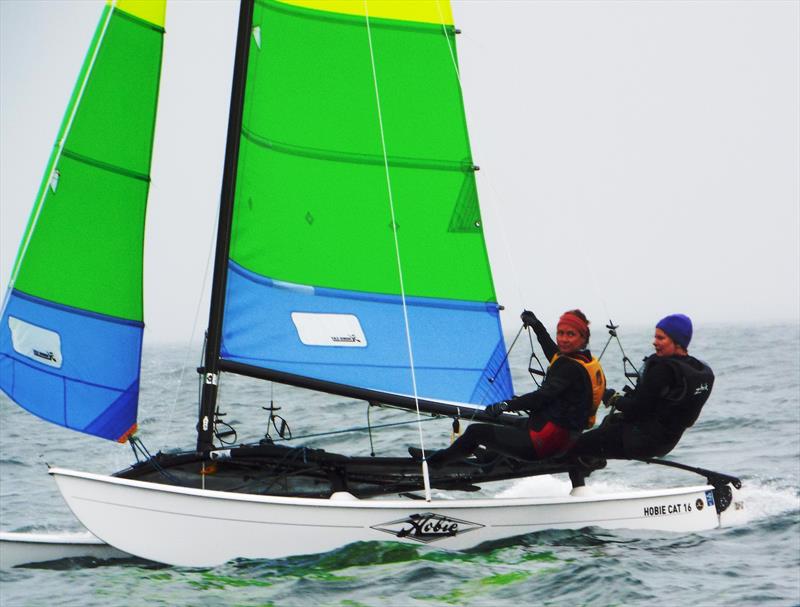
50 468 744 567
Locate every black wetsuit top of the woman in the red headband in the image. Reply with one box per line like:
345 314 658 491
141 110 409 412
508 321 592 432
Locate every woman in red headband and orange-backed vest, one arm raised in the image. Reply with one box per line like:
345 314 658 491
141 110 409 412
409 310 605 466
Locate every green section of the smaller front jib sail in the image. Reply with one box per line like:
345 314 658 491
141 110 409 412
14 7 163 321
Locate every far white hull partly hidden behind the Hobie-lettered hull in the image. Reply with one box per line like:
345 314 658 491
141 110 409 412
0 531 130 569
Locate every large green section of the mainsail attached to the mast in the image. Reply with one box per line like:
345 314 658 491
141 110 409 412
231 0 495 302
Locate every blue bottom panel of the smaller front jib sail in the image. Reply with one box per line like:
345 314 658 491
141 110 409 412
0 290 144 441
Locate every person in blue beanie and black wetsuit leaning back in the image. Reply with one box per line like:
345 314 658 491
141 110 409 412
570 314 714 486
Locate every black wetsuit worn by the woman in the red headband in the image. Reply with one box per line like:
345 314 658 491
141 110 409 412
428 321 592 465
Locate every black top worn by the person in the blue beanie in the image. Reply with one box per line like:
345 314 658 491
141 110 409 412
614 354 714 439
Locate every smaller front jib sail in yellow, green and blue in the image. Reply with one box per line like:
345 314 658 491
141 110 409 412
0 0 165 441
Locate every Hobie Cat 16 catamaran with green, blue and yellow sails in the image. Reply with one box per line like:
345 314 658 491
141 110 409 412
0 0 742 566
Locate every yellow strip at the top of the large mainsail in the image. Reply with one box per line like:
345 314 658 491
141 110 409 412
281 0 453 25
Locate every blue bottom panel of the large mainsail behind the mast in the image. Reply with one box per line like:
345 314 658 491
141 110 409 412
221 261 513 405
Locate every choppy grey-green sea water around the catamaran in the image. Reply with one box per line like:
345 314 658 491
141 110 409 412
0 324 800 607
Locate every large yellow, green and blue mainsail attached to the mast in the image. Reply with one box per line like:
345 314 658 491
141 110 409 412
212 0 513 405
